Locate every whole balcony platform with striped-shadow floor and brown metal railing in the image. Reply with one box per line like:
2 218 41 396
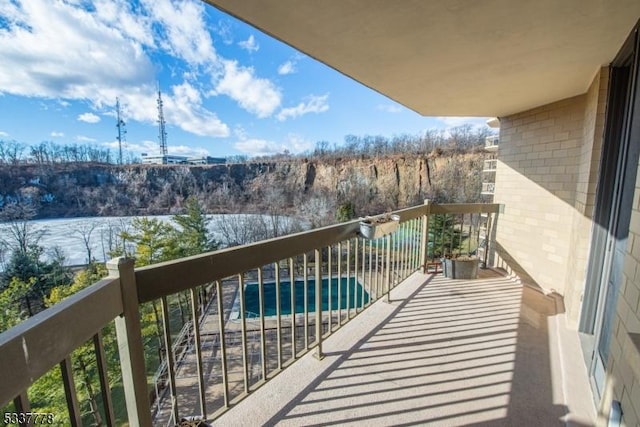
0 203 592 426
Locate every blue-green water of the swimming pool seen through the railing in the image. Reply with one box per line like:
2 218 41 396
244 277 369 316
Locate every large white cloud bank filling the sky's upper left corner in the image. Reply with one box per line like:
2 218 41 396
0 0 154 106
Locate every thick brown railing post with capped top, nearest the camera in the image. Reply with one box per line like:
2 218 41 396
107 257 152 427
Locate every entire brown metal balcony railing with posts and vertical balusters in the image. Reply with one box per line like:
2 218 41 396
0 202 498 426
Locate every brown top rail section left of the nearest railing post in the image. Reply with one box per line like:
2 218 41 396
0 277 122 406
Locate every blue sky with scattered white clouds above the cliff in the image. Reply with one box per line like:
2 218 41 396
0 0 486 157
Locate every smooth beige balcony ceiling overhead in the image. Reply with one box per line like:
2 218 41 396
206 0 640 116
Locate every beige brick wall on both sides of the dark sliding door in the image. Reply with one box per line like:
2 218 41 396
494 68 640 427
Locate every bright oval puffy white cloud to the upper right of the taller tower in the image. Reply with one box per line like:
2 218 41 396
216 60 282 118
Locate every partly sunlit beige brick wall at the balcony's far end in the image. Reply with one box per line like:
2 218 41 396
494 69 608 324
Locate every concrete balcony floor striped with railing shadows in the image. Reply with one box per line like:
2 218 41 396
214 270 595 426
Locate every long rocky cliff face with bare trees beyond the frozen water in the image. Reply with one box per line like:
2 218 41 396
0 153 484 218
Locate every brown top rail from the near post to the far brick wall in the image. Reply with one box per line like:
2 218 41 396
136 203 499 302
